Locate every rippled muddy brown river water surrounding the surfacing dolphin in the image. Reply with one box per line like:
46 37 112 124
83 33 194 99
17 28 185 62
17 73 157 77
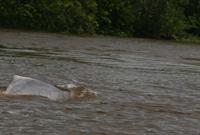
0 31 200 135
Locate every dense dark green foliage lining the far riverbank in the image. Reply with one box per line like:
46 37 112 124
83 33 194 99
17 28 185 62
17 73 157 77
0 0 200 39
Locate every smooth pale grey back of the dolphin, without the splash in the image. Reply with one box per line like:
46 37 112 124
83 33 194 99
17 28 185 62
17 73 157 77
5 75 66 100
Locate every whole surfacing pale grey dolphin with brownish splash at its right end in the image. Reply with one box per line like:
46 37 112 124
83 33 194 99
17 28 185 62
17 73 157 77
4 75 97 101
